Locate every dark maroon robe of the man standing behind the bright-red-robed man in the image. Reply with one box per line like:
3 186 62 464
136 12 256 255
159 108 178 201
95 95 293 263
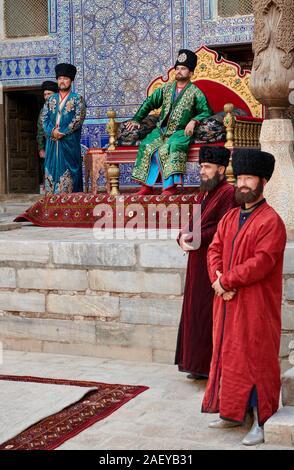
175 180 235 376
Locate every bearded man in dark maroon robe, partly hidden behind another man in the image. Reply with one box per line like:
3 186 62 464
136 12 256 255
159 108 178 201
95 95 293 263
175 147 235 379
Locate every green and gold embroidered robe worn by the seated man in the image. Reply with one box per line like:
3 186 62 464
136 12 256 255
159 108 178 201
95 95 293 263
132 82 212 183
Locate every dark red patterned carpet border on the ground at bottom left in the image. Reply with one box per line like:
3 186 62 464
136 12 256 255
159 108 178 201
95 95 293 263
0 375 148 450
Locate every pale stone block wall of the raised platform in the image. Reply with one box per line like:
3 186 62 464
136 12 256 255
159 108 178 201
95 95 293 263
0 220 294 371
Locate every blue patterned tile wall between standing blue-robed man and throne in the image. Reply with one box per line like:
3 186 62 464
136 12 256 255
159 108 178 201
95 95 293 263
67 0 184 118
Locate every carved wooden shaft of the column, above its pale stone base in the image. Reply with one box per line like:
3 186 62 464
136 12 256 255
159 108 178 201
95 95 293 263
250 0 294 119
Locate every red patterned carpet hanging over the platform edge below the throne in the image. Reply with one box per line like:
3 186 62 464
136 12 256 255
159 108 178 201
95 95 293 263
15 188 197 229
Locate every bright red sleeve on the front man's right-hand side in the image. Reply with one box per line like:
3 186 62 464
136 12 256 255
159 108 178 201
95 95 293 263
221 216 286 290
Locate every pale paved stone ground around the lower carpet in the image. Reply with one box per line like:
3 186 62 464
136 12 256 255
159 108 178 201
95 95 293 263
0 351 293 450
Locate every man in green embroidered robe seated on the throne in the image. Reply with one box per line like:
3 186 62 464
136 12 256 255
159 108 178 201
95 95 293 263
126 49 212 195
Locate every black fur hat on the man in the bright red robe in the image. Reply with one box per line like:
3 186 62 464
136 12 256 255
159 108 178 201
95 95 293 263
232 149 275 181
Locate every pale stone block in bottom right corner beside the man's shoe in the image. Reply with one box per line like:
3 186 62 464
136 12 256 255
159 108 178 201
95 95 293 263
264 406 294 447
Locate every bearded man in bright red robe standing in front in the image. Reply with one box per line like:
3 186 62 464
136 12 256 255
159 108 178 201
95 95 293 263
202 149 286 445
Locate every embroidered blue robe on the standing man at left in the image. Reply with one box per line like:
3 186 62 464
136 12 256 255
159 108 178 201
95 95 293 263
42 92 86 194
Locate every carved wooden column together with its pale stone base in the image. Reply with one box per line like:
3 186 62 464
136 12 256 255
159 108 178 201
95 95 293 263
250 0 294 238
